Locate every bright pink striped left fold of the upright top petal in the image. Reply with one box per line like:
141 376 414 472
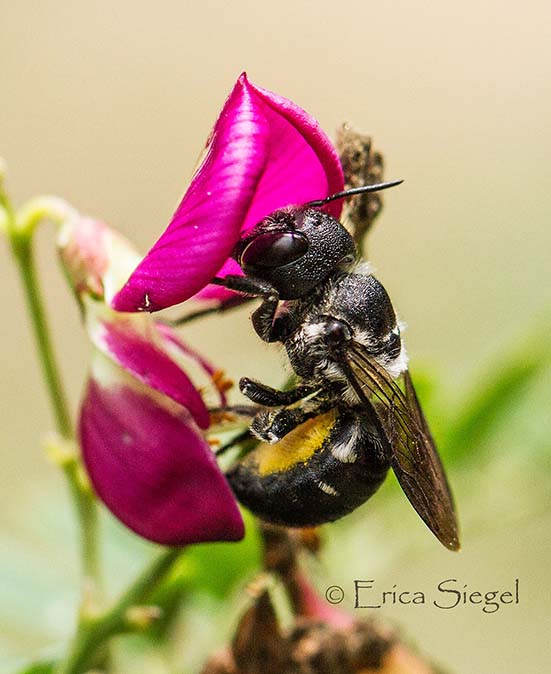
113 80 269 311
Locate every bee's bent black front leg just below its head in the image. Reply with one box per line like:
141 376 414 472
212 275 288 342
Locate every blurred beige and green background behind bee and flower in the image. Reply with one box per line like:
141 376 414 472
0 0 551 674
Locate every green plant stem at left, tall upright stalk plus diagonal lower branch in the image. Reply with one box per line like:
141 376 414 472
0 192 181 674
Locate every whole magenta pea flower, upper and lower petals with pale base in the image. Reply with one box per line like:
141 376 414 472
60 75 343 545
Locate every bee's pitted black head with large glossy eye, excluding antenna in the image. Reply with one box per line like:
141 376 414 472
233 206 356 299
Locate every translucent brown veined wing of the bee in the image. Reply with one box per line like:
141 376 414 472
345 343 459 550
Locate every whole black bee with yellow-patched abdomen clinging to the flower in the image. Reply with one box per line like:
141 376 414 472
214 182 459 550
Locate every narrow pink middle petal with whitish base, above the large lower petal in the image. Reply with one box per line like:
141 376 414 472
92 316 210 428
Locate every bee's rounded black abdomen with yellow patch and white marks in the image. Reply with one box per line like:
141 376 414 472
227 410 389 527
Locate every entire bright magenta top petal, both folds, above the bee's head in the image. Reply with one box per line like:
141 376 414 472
113 74 343 311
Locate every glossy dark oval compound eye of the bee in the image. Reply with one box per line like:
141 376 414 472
240 232 308 268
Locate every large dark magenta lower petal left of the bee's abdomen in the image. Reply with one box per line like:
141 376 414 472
79 380 244 545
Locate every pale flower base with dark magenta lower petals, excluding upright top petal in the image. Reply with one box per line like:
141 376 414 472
59 217 244 545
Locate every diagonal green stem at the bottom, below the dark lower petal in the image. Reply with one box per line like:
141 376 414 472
56 548 182 674
